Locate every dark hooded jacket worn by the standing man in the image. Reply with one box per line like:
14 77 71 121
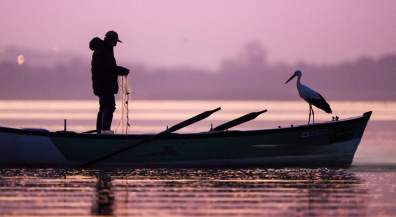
89 37 126 96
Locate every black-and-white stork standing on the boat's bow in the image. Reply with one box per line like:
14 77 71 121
285 70 331 124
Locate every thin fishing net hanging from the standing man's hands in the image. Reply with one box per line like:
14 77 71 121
116 75 130 134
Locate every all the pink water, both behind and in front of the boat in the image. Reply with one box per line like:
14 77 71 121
0 100 396 216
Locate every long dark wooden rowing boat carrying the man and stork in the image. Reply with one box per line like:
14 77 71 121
0 108 372 167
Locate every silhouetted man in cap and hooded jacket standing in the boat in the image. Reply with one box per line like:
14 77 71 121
89 31 129 133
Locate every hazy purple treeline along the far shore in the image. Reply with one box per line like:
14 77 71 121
0 43 396 101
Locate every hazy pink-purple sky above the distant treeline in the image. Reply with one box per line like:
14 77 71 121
0 0 396 69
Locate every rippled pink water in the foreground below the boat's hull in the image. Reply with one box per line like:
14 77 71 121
0 168 396 216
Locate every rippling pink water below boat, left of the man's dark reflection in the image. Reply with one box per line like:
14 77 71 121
0 169 97 216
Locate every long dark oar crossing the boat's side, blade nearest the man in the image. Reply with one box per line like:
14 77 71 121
81 107 221 167
